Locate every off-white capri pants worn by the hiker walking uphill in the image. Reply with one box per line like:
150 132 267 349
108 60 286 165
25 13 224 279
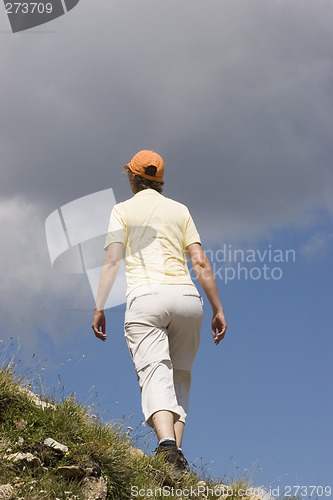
125 284 203 426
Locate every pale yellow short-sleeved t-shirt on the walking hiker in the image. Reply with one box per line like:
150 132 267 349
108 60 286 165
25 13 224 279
104 189 201 294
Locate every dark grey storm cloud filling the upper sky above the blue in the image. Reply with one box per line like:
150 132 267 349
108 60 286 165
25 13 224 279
0 0 333 336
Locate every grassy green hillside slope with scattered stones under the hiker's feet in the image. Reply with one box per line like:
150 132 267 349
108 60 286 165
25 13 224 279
0 367 272 500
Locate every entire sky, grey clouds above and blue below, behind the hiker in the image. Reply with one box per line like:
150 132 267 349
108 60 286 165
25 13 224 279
0 0 333 493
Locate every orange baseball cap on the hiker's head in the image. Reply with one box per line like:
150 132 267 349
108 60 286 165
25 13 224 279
125 149 164 182
